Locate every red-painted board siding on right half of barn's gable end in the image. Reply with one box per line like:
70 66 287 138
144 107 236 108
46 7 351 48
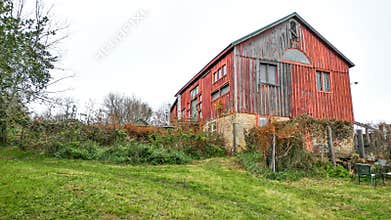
291 25 354 122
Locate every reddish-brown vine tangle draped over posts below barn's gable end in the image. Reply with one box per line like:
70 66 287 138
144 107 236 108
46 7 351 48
245 115 353 169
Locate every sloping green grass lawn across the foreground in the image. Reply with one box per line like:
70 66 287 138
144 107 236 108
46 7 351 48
0 148 391 219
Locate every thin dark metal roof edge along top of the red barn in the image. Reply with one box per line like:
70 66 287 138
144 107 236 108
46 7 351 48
175 12 354 96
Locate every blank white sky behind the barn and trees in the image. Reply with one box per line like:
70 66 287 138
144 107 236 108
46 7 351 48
33 0 391 122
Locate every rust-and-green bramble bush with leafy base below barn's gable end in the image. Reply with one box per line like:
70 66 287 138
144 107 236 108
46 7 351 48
237 115 353 180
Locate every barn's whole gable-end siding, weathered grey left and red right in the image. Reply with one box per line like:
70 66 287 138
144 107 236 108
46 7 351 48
234 17 354 121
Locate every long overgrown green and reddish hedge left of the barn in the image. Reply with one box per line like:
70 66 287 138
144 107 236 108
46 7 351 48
15 119 226 164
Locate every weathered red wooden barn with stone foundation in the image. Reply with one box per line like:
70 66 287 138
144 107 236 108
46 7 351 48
171 13 354 151
